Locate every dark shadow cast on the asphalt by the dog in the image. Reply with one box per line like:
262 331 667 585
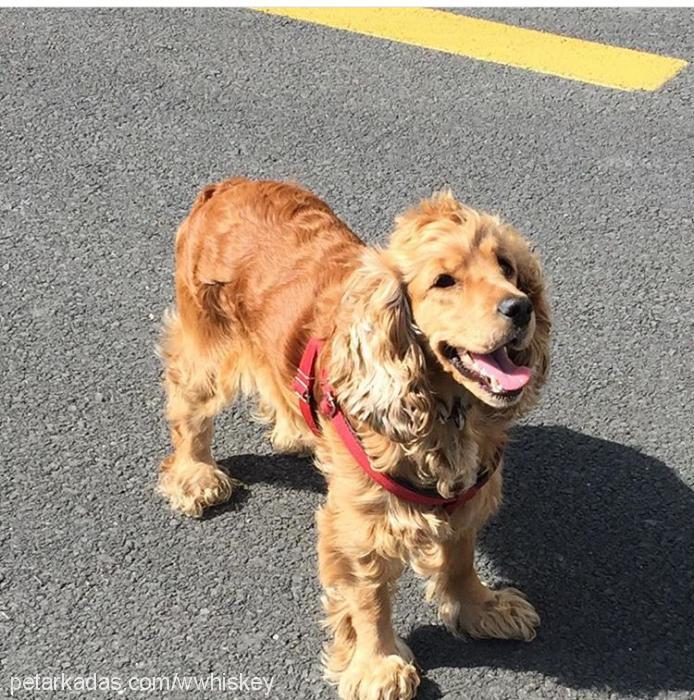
221 426 694 700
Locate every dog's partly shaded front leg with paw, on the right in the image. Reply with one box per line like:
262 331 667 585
413 530 540 641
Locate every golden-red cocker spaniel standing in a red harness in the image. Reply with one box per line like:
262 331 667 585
158 178 550 700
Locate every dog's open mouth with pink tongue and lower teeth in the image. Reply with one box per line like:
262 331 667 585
442 344 532 403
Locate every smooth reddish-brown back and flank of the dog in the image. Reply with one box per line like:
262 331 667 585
176 178 363 363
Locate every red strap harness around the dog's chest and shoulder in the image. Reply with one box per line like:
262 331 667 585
292 338 492 513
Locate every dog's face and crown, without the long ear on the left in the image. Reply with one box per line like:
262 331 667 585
388 191 550 410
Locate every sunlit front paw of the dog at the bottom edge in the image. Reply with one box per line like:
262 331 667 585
338 649 419 700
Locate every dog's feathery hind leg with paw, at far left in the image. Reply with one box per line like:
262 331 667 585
158 312 233 517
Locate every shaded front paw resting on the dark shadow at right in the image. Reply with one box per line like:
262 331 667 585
439 588 540 642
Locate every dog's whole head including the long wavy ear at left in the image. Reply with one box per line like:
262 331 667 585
328 192 550 442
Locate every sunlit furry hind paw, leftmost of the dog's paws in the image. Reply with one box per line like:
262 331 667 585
157 458 235 518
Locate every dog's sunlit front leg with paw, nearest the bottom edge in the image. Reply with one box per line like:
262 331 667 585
318 501 419 700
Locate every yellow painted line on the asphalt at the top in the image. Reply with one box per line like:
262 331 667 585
261 7 687 91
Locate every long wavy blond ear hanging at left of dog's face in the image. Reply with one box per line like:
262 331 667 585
329 249 434 443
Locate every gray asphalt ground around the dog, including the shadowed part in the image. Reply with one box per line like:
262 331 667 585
0 9 694 700
